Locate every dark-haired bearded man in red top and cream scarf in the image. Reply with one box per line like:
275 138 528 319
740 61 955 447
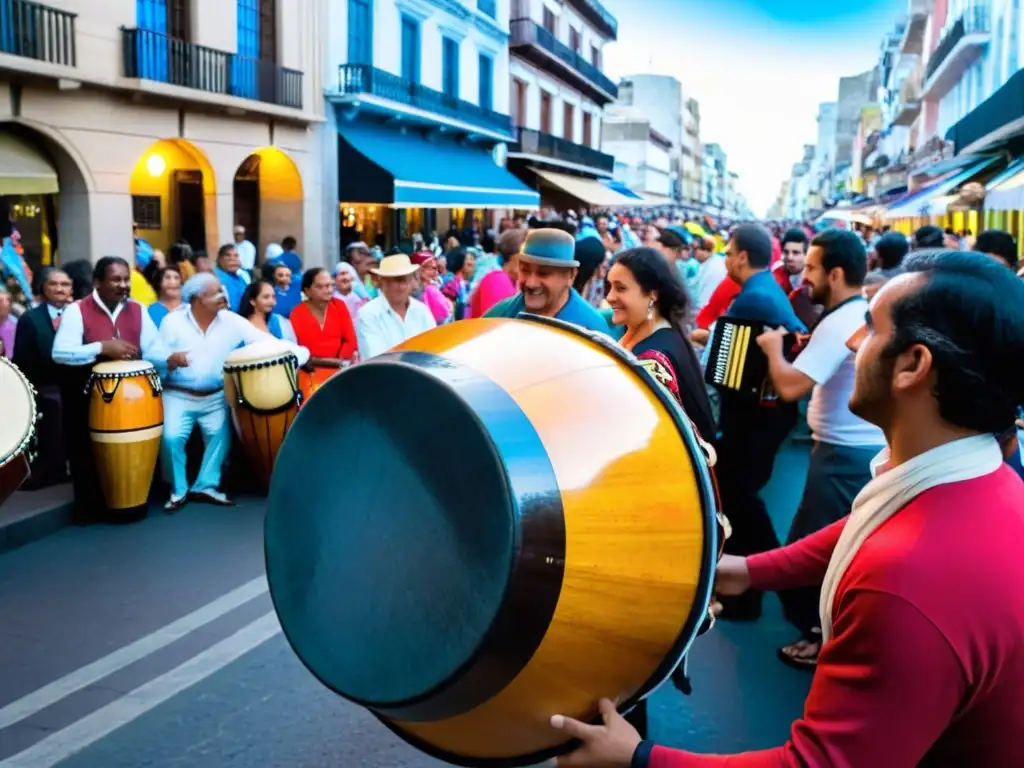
552 252 1024 768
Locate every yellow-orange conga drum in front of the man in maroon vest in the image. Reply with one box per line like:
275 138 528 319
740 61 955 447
86 360 164 511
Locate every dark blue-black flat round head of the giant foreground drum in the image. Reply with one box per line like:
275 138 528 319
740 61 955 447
265 364 516 707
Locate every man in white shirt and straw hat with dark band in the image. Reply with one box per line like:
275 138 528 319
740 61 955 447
355 253 437 360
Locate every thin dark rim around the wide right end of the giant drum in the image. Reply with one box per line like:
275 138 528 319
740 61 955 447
371 313 718 768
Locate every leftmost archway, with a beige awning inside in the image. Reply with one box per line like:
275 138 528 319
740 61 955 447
0 122 91 282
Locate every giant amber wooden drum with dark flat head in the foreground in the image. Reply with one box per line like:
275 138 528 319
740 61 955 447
265 316 719 766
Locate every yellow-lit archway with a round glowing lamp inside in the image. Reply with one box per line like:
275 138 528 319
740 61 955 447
130 138 218 253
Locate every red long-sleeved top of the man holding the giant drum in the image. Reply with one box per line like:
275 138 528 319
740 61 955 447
647 473 1024 768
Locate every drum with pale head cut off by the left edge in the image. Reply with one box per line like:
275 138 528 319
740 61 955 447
0 355 37 504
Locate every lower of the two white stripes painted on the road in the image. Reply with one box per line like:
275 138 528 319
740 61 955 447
0 611 281 768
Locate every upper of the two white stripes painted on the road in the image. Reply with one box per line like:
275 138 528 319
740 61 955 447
0 577 267 729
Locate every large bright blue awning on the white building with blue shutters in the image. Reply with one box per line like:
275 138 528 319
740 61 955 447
338 121 541 210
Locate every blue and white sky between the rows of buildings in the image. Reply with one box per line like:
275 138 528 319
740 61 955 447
601 0 907 216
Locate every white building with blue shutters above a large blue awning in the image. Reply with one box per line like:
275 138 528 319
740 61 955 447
323 0 539 259
